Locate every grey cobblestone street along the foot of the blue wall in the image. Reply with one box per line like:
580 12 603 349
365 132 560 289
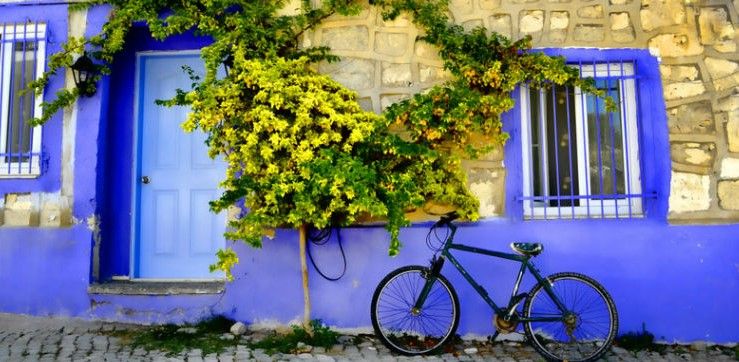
0 314 735 362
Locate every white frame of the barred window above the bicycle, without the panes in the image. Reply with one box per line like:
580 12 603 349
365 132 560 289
520 62 643 219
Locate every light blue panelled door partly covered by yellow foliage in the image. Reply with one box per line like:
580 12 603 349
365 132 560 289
133 53 226 279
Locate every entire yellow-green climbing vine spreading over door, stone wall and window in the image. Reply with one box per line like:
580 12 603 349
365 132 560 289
31 0 613 270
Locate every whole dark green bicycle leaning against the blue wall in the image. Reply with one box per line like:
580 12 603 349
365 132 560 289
371 212 618 361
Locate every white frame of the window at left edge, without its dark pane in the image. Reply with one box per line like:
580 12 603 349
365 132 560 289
0 23 46 178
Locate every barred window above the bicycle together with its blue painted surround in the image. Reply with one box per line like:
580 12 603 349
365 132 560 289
506 49 669 220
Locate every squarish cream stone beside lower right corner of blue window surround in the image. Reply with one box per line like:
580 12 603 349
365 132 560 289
669 171 711 213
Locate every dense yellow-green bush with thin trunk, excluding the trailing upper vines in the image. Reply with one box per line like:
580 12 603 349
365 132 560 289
183 53 477 328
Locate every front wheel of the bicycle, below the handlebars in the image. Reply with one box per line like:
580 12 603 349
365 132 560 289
371 266 459 355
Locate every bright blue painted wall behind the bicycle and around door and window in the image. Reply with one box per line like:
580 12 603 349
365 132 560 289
0 4 739 342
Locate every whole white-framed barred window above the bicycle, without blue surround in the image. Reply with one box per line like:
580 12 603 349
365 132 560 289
521 62 644 219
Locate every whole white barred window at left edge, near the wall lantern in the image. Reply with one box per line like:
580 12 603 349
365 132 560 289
0 23 46 177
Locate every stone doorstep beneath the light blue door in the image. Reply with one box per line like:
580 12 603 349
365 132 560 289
87 281 226 295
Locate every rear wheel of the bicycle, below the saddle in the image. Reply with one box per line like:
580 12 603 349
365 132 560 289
523 273 618 361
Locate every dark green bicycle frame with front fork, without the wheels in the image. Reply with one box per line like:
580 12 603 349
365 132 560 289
414 222 570 322
